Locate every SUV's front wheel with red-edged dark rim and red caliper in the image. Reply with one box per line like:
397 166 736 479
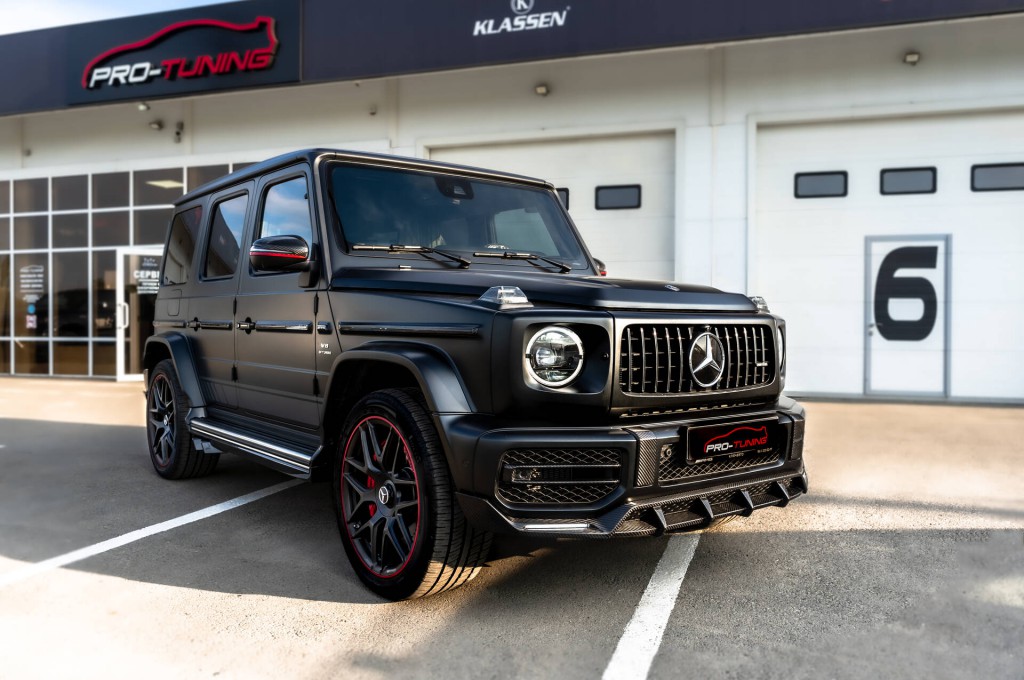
333 389 492 600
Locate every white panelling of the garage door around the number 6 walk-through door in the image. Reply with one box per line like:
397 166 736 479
751 113 1024 399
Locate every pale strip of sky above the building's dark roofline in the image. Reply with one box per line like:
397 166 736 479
0 0 234 35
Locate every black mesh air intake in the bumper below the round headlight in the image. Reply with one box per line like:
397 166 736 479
498 449 624 505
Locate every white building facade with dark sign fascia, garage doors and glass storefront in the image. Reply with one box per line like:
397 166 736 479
0 0 1024 401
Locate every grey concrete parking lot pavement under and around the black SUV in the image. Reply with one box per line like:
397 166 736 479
0 378 1024 680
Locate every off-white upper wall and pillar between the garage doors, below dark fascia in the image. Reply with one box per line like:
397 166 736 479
0 16 1024 292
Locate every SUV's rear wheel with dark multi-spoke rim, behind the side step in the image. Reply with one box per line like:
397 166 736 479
145 359 220 479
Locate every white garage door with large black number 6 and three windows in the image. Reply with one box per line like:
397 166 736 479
751 113 1024 399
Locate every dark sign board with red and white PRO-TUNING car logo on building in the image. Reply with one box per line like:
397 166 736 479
66 0 301 104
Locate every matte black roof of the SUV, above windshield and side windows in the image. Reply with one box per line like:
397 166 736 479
180 148 554 205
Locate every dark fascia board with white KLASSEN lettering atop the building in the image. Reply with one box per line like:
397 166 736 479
302 0 1024 81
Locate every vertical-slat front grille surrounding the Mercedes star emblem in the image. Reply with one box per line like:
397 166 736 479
618 324 775 394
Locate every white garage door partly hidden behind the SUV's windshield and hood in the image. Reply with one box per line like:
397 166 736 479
430 133 676 281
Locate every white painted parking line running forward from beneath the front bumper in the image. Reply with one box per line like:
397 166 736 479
602 534 700 680
